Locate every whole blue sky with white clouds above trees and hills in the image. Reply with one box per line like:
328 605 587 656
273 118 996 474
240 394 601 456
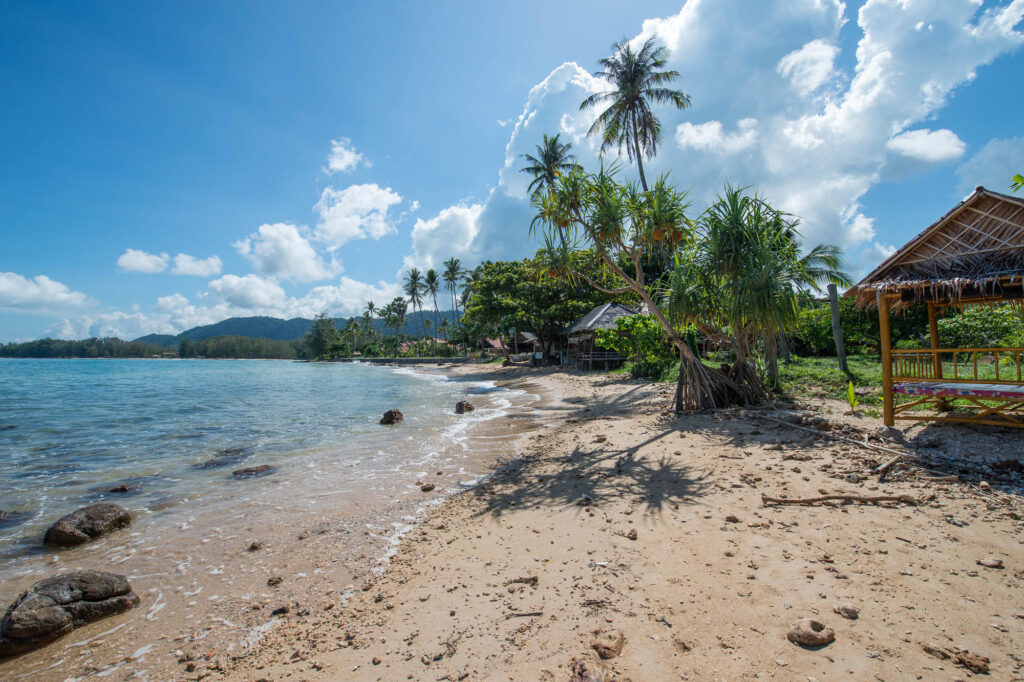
0 0 1024 340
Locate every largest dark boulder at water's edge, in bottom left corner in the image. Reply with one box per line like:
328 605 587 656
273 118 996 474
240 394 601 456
0 570 139 658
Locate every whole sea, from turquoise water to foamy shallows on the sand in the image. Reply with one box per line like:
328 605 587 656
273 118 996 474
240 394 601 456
0 358 538 677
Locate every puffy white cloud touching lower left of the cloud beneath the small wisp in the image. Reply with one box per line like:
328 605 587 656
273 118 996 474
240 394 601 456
233 222 339 282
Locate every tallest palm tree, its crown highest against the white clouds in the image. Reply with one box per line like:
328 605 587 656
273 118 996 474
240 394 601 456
580 38 690 191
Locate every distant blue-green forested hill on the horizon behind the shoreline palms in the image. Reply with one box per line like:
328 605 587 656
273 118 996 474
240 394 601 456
135 310 455 348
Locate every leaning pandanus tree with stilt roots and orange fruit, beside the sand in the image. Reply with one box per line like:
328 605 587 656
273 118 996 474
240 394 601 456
531 166 741 412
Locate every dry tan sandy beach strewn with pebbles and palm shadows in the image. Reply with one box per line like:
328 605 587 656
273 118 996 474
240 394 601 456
220 366 1024 682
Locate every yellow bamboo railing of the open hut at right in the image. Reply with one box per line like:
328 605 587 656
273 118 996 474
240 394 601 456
892 348 1024 384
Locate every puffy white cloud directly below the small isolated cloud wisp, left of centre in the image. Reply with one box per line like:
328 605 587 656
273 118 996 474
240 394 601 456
313 183 401 251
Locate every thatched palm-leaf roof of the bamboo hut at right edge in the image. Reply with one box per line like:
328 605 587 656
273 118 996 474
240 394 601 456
846 187 1024 308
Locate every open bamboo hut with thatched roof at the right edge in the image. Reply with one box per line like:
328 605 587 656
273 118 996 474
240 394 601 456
846 187 1024 427
